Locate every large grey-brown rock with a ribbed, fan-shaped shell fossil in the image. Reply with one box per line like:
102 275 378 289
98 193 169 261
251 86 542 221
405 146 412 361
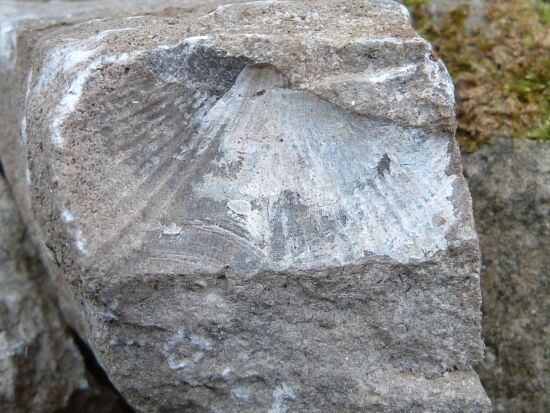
0 1 490 412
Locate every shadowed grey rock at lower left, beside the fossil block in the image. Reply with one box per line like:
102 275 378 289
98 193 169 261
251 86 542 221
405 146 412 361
0 176 130 413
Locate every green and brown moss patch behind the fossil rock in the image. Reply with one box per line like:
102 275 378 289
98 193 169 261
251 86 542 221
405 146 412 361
404 0 550 150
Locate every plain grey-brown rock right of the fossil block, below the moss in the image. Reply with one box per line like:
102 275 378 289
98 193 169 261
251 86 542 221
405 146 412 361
464 139 550 413
